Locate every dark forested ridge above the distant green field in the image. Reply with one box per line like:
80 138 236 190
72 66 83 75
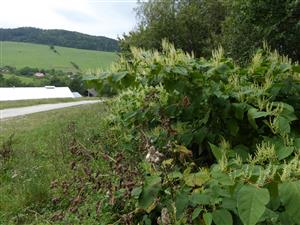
0 27 119 52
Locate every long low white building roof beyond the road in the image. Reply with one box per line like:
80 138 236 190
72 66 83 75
0 86 74 101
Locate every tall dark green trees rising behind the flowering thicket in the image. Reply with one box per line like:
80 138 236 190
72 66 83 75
120 0 300 63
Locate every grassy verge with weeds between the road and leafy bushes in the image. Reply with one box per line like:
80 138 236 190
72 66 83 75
0 104 117 224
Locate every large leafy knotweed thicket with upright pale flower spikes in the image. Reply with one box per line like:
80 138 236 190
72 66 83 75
87 41 300 225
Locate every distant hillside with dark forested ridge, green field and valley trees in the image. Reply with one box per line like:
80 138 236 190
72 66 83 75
0 28 119 94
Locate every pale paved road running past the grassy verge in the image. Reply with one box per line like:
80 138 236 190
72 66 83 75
0 100 101 120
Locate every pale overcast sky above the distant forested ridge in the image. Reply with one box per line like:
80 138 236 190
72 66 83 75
0 0 141 38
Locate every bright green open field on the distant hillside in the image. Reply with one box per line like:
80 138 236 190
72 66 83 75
0 41 118 71
